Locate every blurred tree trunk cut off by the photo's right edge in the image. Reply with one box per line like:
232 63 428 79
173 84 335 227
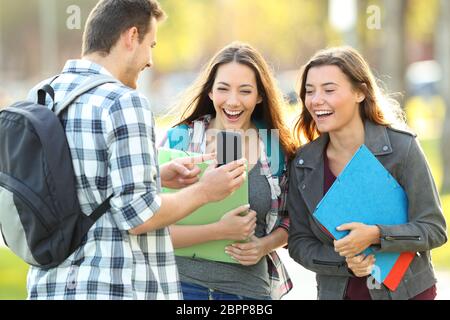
435 0 450 194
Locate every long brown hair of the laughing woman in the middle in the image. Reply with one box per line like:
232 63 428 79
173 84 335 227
173 42 297 158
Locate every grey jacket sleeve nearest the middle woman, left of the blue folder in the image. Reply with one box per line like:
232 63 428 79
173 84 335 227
287 162 352 276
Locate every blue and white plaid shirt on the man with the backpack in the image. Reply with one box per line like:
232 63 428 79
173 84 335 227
27 60 182 299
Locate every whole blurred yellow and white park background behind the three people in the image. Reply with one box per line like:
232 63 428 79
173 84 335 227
0 0 450 299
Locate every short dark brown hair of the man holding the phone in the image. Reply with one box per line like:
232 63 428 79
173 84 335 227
82 0 166 56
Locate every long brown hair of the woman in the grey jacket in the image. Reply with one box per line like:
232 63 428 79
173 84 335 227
294 46 405 142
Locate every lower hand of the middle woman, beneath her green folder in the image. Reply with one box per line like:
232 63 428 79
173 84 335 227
225 236 267 266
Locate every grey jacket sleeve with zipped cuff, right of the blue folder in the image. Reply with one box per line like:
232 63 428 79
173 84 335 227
378 139 447 252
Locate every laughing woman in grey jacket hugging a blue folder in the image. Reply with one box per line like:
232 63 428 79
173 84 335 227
288 47 447 300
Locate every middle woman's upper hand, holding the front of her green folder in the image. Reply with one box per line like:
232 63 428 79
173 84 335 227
216 205 256 241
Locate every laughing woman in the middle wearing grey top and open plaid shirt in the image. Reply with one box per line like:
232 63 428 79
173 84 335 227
163 42 295 299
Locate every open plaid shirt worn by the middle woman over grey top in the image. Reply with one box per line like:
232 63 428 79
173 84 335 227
159 115 293 299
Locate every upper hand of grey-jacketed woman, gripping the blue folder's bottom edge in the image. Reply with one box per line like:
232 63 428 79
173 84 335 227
334 222 380 258
